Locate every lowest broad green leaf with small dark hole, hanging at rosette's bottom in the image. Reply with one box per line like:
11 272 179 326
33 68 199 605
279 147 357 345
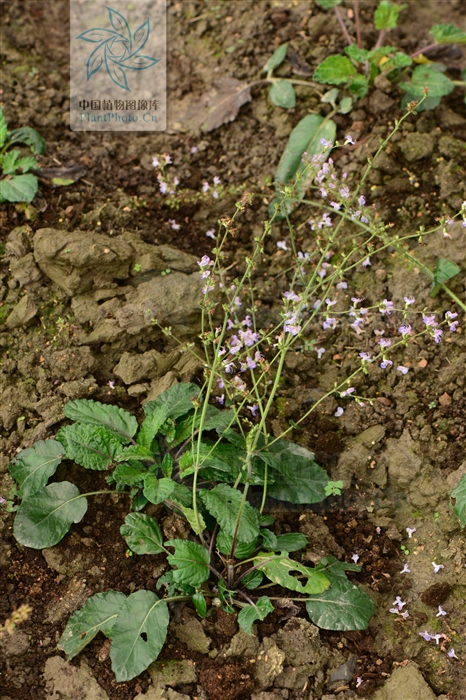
110 591 169 683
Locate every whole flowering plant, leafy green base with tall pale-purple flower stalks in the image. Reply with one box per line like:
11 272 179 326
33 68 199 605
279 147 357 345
9 97 466 681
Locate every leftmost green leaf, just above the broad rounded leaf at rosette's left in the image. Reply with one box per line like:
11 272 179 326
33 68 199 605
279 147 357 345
9 440 65 499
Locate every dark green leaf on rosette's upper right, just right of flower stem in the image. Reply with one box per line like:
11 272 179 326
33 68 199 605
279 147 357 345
259 440 328 503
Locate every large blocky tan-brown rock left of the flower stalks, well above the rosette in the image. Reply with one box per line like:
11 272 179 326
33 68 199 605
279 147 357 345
33 228 134 296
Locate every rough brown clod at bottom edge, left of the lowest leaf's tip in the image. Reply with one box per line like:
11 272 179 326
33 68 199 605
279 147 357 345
44 656 109 700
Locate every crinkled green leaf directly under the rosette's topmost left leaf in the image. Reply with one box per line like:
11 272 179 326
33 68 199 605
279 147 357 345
57 423 121 471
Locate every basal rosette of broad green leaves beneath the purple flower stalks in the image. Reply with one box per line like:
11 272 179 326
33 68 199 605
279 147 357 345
9 384 375 682
